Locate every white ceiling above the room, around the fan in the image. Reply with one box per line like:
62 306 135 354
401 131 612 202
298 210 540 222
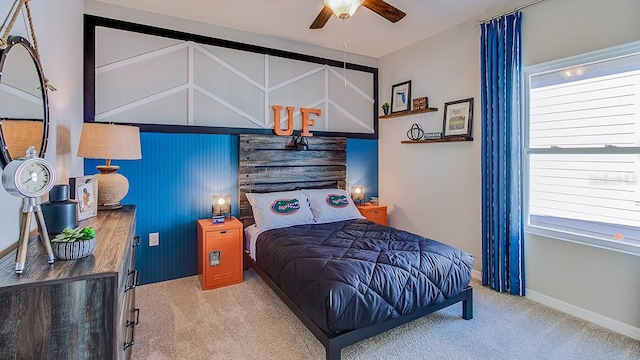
98 0 512 58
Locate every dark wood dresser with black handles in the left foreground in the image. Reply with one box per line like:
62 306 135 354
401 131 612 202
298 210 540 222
0 205 140 359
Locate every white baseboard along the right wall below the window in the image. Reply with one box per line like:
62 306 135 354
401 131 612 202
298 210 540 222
524 286 640 340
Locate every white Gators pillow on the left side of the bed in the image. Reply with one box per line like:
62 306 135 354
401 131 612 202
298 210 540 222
246 190 313 231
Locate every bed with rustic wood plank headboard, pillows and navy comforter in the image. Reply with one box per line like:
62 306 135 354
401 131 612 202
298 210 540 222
239 135 474 360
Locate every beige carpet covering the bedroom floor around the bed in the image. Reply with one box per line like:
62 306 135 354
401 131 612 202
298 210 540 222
133 270 640 360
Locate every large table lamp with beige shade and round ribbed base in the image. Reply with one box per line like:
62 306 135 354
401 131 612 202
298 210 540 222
78 123 142 210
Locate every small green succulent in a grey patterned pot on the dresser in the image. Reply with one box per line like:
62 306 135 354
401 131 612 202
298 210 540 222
51 226 96 260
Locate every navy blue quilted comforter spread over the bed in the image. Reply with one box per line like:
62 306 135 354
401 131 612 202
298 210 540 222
256 220 474 334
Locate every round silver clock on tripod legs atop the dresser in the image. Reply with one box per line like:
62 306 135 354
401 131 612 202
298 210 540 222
2 146 56 274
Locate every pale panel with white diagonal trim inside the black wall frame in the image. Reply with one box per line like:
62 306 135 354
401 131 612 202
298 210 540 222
95 27 375 134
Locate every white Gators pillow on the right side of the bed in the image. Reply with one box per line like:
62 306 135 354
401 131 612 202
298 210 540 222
302 189 364 223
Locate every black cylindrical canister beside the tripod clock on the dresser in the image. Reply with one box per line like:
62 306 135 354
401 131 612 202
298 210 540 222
40 184 78 236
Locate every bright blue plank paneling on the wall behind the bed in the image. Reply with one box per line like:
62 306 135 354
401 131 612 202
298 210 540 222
84 132 378 284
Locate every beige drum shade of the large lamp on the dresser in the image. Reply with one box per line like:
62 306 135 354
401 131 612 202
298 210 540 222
78 123 142 160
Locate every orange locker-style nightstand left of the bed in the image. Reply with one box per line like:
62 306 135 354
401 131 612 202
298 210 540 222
198 217 242 290
